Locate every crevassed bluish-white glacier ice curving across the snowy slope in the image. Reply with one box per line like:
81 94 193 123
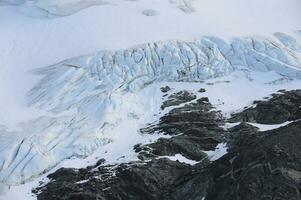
0 33 301 189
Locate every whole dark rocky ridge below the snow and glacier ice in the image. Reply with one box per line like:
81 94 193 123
34 90 301 200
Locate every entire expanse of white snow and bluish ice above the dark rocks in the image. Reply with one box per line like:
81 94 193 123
0 0 301 200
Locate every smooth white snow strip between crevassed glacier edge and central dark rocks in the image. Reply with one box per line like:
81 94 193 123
61 84 166 168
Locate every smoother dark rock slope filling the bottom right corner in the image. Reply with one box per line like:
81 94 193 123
206 121 301 200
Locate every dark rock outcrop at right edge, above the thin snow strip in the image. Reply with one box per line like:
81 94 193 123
229 90 301 124
